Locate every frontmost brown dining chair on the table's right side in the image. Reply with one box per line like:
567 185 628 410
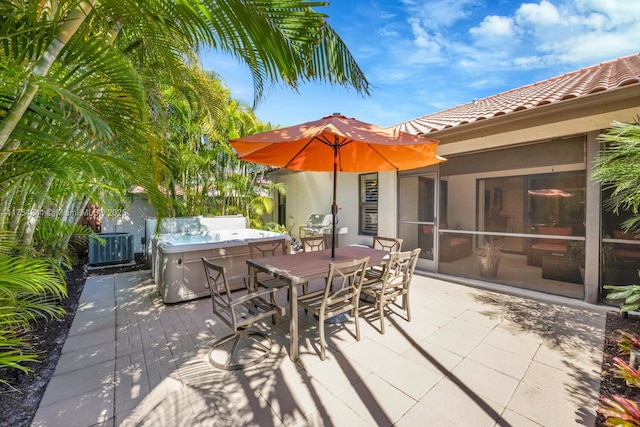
298 257 369 360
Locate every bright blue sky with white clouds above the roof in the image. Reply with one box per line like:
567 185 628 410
202 0 640 126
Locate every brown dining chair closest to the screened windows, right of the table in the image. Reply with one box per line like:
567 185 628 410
361 248 420 334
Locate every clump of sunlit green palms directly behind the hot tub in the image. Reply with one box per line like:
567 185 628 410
157 74 277 222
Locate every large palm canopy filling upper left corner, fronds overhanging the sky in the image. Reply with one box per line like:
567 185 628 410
0 0 368 244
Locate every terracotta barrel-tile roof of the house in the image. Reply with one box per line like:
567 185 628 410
392 54 640 134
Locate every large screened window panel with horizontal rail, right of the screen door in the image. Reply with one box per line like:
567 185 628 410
432 136 588 299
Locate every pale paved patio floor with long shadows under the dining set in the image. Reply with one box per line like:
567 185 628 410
32 271 606 427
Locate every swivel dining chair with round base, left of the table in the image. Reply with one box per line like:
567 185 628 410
202 258 284 370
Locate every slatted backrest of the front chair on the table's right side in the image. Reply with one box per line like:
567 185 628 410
322 257 369 308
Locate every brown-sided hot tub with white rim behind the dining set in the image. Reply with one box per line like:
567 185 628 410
153 228 291 303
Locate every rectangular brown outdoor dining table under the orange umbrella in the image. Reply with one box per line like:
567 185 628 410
247 246 389 361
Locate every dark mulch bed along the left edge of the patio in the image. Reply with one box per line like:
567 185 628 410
0 257 148 427
